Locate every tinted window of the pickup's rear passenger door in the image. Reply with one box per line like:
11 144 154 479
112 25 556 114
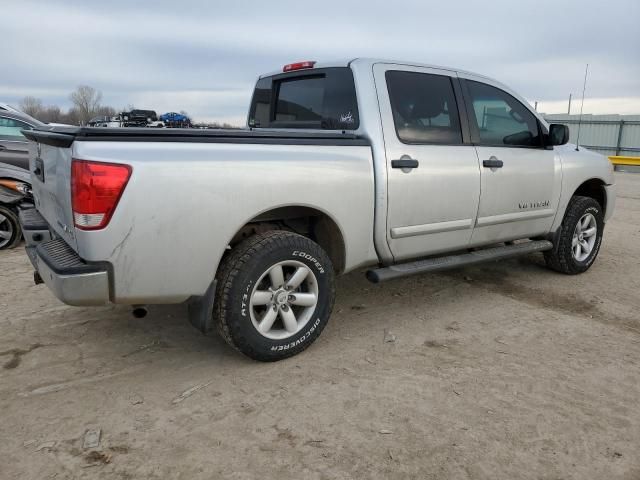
385 70 462 144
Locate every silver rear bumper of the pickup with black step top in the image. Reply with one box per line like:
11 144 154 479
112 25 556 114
20 209 110 305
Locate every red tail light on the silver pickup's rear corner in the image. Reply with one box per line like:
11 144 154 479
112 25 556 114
71 158 131 230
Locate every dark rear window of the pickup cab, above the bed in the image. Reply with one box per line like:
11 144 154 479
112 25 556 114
249 67 360 130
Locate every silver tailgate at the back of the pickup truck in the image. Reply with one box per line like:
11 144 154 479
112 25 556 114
23 130 78 251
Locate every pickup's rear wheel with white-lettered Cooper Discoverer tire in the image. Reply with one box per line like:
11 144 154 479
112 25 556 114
213 231 335 362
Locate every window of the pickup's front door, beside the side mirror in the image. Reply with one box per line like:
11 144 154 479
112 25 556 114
467 80 542 147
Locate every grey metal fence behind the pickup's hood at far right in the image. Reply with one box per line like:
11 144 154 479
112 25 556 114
544 114 640 157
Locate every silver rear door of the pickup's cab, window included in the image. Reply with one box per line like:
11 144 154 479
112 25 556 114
374 64 480 261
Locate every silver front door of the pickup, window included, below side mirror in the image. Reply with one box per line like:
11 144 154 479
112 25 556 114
461 79 561 245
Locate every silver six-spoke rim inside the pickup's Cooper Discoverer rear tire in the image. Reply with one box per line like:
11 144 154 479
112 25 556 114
249 260 318 340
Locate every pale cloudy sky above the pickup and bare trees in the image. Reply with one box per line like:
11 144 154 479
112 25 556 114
0 0 640 126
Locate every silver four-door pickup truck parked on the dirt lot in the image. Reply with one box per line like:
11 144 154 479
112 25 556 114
21 59 615 361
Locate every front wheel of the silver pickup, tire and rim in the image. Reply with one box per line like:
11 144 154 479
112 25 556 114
544 196 604 275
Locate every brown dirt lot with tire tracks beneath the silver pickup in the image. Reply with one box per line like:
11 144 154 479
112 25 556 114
0 174 640 480
